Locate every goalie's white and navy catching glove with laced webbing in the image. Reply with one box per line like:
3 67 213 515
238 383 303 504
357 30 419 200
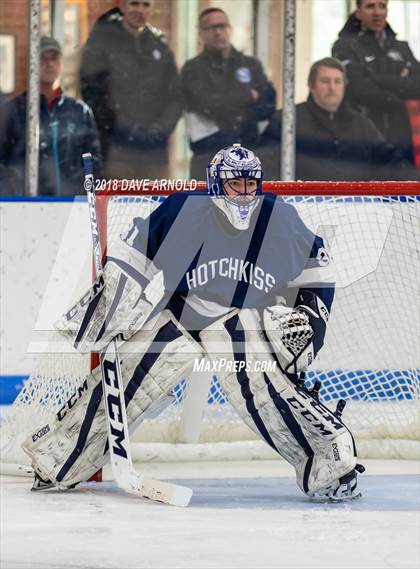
263 290 329 374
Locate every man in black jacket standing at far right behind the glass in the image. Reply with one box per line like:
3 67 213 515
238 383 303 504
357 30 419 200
332 0 420 168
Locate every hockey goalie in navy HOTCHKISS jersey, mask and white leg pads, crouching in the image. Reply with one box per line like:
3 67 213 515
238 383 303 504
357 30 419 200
23 144 363 500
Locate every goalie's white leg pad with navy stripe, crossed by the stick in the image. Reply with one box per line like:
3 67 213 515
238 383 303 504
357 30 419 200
22 311 203 488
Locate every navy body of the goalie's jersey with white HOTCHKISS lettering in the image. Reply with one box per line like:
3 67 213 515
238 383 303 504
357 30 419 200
128 192 332 305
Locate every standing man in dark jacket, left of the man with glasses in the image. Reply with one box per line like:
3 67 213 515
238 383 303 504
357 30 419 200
80 0 181 179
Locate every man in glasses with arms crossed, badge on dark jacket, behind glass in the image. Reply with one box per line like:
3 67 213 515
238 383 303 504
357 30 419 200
181 8 276 179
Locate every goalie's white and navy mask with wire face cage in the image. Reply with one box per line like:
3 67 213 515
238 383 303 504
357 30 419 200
207 144 263 229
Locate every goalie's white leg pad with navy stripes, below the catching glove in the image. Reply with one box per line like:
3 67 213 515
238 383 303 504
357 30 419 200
200 309 356 493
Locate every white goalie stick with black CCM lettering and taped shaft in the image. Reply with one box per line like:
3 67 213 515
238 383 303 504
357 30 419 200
82 153 192 506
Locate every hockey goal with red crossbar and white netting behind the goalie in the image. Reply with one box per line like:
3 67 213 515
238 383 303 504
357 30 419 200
0 182 420 471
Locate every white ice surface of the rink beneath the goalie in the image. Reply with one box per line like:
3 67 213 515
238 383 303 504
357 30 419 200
0 461 420 569
